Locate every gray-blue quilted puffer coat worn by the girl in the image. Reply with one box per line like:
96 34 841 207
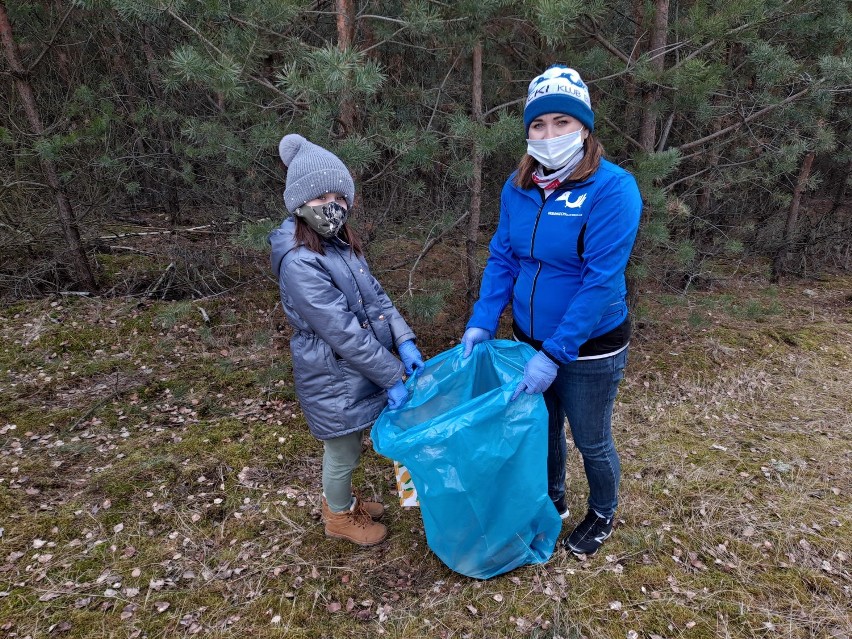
269 217 414 439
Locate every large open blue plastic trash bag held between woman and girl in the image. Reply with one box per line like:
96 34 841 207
371 340 562 579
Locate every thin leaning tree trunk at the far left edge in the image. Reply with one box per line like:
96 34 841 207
0 1 98 292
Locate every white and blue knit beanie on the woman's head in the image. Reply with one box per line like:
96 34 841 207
524 64 595 131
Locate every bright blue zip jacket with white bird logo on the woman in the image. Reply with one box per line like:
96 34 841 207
467 160 642 362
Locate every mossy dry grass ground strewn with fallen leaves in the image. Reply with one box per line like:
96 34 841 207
0 268 852 639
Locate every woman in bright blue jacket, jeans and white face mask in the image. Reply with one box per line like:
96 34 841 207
462 65 642 555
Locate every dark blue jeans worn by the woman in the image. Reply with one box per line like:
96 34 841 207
544 349 627 519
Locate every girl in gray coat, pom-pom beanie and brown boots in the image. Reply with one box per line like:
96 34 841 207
269 135 423 546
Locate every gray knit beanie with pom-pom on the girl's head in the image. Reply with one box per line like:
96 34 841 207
278 133 355 213
